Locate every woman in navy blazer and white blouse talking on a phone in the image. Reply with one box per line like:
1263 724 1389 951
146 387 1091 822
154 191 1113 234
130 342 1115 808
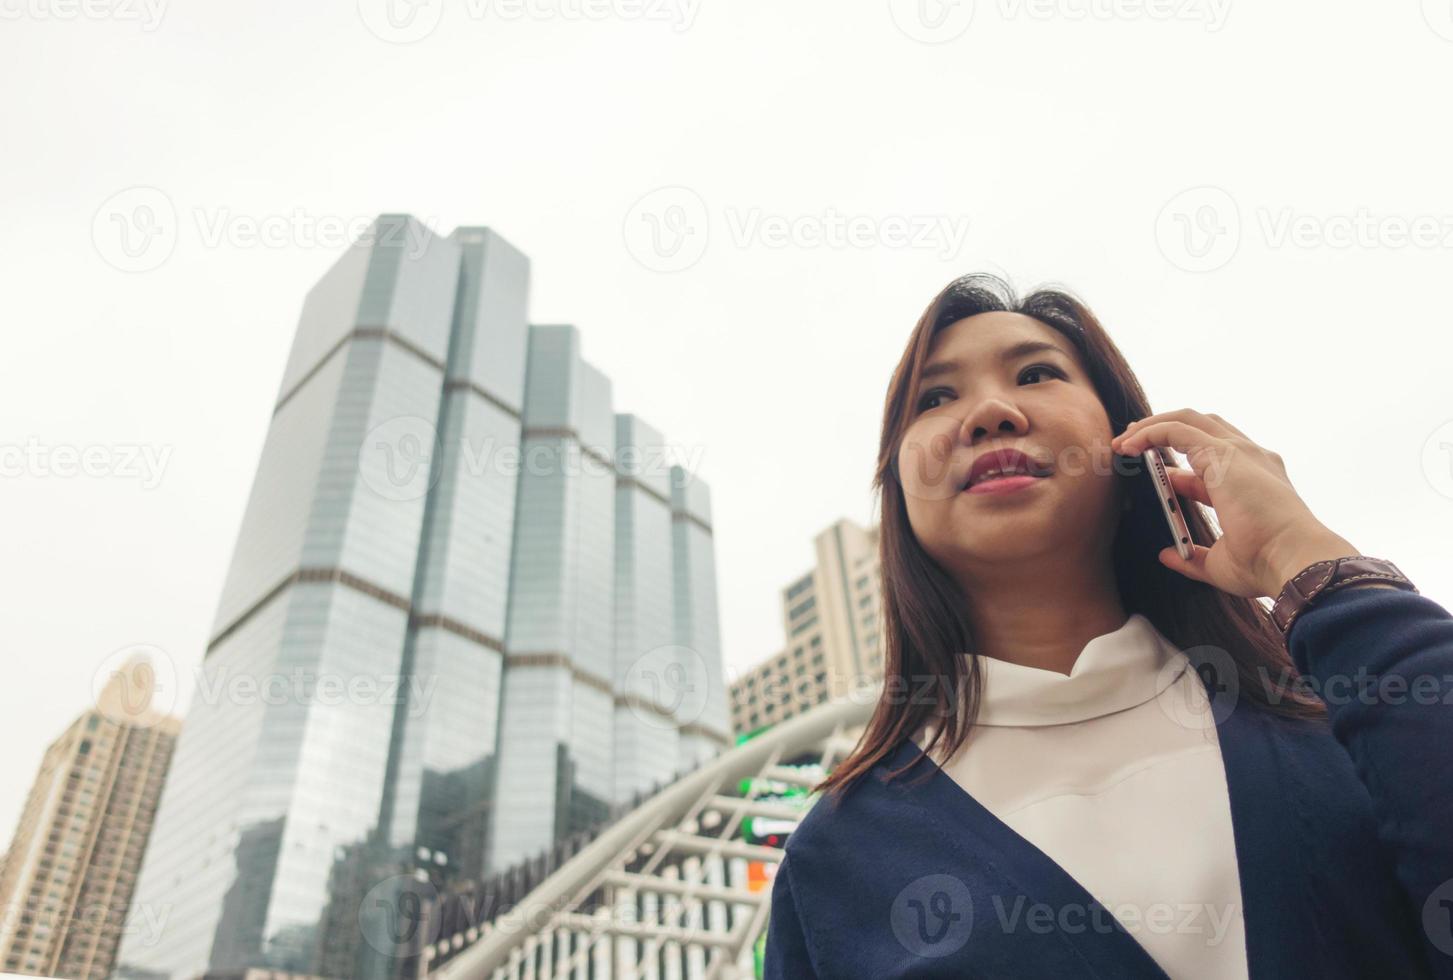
766 276 1453 980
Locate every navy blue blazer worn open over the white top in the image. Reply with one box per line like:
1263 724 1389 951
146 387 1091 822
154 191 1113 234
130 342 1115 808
766 589 1453 980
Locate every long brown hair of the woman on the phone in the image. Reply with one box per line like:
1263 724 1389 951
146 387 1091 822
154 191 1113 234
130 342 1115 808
814 273 1327 798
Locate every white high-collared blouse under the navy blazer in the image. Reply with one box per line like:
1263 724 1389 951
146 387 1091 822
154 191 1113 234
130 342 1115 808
914 614 1247 980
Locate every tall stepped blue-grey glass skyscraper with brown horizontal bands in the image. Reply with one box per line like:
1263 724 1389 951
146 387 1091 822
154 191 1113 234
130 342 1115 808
111 215 728 980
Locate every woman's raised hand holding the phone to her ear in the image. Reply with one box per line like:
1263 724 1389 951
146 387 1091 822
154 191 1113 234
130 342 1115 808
1110 409 1360 596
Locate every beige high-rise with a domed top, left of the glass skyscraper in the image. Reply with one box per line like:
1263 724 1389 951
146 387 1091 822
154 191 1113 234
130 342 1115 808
0 656 182 980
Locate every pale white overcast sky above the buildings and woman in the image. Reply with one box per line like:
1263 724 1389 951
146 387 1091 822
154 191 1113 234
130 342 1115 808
0 0 1453 846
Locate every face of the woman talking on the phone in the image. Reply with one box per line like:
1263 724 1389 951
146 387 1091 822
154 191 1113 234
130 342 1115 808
898 313 1120 573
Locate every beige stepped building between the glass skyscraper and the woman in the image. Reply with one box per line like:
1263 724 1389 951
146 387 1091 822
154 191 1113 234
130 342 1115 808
731 518 883 734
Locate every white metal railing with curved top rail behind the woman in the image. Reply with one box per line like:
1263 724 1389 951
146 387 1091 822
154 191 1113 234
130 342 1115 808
421 689 876 980
